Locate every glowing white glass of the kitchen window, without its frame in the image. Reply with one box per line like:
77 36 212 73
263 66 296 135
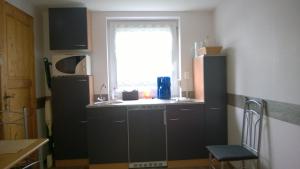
115 27 173 90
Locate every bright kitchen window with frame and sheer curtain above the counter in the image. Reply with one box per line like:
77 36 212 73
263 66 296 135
107 19 179 97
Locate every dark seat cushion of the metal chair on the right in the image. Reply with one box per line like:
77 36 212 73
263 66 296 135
206 145 257 161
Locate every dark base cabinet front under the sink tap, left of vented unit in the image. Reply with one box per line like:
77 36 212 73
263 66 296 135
88 107 128 164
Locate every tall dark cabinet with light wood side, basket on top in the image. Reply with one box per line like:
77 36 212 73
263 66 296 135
194 55 227 148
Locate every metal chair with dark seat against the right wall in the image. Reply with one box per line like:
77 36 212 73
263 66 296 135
206 98 265 169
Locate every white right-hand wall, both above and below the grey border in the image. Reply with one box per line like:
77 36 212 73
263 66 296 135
215 0 300 169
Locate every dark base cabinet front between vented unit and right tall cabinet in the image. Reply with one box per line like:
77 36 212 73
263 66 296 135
167 104 206 160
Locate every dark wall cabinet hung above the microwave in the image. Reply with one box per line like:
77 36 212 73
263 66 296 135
49 8 91 50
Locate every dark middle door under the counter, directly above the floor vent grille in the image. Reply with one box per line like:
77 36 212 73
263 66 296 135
128 109 166 162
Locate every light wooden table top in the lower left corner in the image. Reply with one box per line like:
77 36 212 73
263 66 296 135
0 139 48 169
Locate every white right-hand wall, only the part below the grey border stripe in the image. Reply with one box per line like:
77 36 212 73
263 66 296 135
228 106 300 169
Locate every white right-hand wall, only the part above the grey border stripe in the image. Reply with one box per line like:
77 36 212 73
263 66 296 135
216 0 300 104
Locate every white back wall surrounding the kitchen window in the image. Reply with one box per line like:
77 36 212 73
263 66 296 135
90 11 215 93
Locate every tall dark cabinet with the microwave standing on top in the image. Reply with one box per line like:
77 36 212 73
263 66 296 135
52 76 93 160
